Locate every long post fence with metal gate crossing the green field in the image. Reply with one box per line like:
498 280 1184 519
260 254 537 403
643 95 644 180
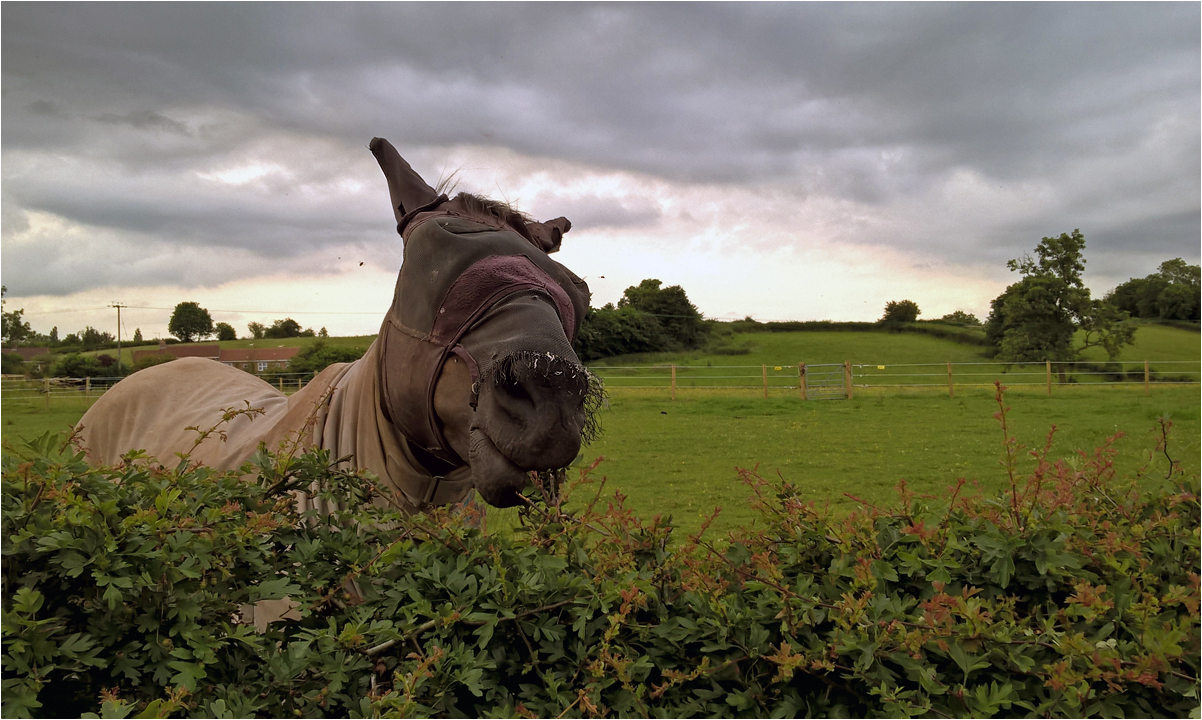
0 361 1202 407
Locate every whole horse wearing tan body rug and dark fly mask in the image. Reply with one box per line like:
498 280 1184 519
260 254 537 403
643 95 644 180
76 138 602 513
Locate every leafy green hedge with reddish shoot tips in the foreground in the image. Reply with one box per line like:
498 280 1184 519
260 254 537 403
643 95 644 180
2 387 1200 718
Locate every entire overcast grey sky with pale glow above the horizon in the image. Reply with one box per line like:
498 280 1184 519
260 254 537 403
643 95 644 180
0 1 1202 338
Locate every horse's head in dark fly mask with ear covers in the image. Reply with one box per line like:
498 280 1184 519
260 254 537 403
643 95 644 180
370 138 601 507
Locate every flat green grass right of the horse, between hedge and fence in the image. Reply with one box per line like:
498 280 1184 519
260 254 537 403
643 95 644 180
540 386 1202 538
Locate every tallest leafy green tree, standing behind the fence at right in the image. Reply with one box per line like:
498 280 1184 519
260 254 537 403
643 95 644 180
986 230 1135 382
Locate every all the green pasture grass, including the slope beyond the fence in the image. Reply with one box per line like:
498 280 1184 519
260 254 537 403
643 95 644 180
2 326 1202 540
